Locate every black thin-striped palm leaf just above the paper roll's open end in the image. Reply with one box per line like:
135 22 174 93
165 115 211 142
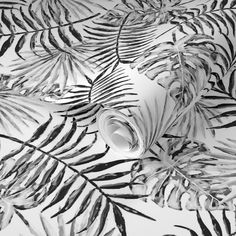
57 67 138 122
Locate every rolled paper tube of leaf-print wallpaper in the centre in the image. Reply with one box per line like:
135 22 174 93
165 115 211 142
97 66 177 157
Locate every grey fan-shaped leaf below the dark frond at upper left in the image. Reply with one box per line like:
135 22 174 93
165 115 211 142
9 43 92 95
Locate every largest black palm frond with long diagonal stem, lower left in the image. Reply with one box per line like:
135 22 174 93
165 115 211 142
0 114 155 235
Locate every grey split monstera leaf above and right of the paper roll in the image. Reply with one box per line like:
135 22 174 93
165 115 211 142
131 33 214 107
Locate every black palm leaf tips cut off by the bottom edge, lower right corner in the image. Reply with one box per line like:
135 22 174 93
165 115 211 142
167 210 234 236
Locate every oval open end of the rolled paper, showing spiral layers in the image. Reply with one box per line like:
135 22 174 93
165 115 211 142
97 108 146 158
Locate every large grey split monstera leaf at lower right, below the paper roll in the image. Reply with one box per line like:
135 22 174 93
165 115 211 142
132 138 235 210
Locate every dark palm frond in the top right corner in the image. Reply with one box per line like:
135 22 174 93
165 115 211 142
170 0 236 35
